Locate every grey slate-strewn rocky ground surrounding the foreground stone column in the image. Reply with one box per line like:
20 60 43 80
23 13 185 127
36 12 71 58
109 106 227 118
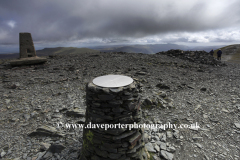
0 50 240 160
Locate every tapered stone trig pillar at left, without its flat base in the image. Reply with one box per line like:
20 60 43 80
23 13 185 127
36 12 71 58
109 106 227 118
19 33 37 58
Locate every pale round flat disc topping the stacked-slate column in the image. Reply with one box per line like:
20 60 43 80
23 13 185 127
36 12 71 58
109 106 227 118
93 75 133 88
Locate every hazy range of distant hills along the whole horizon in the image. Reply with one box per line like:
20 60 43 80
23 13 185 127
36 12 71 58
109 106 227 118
0 43 234 59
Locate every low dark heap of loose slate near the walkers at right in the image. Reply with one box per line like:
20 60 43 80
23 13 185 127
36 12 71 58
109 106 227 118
156 49 225 66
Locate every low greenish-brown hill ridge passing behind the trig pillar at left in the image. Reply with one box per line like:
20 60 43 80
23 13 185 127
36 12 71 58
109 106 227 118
0 47 99 59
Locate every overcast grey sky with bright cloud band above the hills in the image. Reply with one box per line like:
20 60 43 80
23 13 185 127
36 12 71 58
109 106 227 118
0 0 240 52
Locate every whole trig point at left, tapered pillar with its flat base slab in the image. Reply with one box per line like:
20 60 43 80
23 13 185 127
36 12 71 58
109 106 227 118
10 33 47 66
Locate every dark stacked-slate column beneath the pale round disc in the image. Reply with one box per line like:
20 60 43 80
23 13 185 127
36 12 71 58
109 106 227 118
80 82 148 160
